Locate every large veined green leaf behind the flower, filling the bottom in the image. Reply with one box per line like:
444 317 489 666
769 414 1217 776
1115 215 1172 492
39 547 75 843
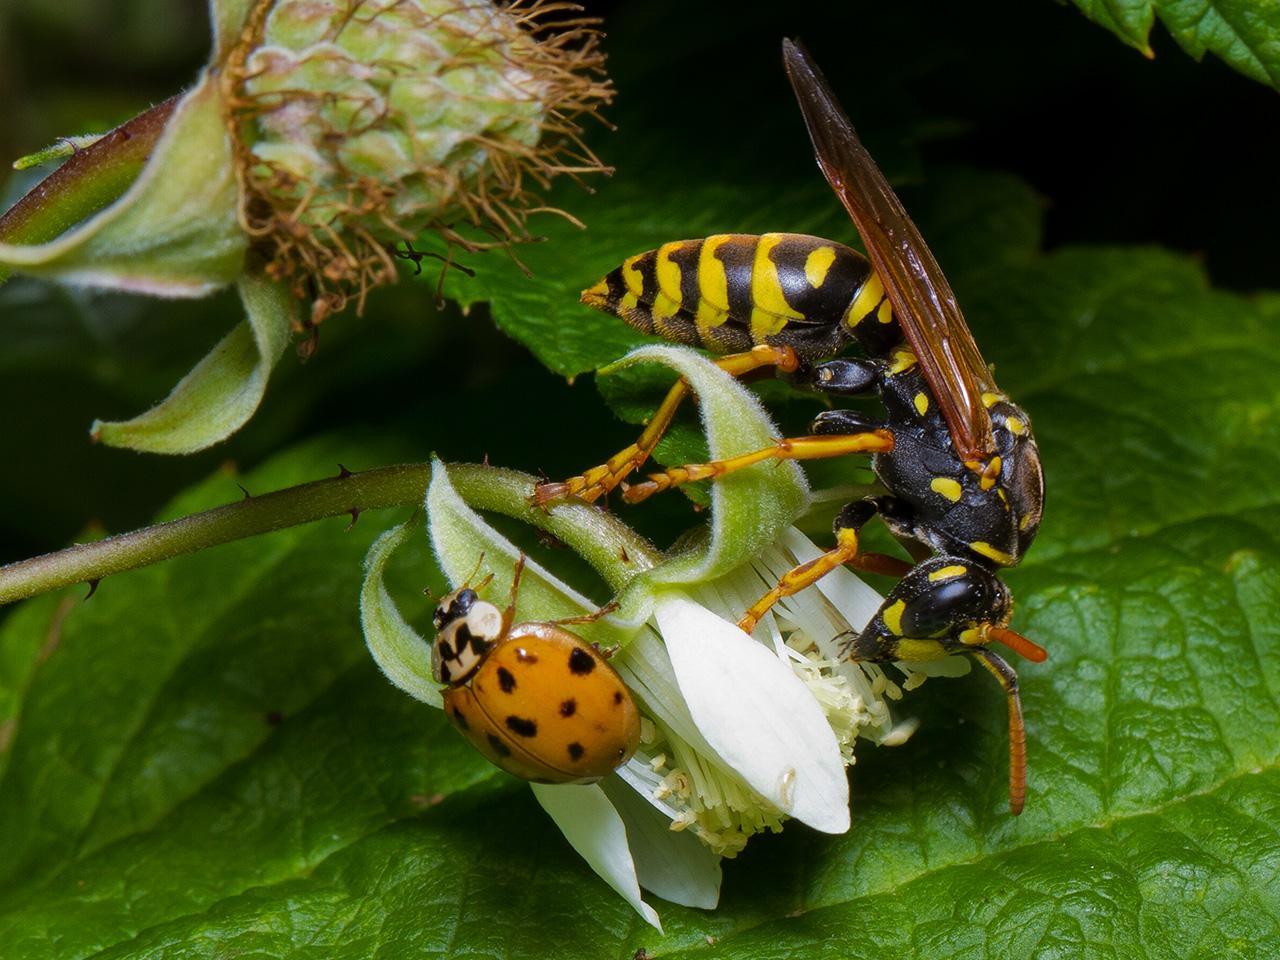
0 213 1280 957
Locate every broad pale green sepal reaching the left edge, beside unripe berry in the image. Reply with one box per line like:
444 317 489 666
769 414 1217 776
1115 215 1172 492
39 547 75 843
0 74 247 297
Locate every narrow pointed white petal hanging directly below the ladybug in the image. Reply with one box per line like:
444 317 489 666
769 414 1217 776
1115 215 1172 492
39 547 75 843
530 783 662 932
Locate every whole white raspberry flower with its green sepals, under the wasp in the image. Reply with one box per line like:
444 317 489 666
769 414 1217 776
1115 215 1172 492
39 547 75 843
361 347 952 927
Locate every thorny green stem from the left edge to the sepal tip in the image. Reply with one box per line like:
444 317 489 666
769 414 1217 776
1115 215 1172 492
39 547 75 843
0 463 431 604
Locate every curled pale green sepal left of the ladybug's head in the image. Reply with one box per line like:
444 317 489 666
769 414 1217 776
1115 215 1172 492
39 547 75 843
360 517 443 708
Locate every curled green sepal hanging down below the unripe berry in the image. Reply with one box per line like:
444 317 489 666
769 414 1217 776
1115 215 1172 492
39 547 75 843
90 268 298 453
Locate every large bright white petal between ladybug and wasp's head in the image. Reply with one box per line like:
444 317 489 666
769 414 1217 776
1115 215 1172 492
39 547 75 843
655 593 849 833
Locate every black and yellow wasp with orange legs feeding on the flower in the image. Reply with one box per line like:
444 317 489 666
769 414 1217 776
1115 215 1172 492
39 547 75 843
535 40 1047 814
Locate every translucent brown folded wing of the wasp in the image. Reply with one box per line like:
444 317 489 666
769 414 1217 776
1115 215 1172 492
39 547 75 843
782 40 996 461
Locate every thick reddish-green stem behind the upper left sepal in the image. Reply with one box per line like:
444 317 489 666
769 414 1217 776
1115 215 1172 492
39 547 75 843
0 96 179 282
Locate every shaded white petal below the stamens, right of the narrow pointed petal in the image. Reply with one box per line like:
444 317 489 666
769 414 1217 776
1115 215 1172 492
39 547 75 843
600 777 722 910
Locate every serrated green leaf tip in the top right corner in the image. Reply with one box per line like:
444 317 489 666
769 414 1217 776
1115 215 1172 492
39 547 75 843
1073 0 1280 88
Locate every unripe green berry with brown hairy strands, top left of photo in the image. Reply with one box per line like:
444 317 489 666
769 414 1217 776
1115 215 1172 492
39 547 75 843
225 0 612 324
